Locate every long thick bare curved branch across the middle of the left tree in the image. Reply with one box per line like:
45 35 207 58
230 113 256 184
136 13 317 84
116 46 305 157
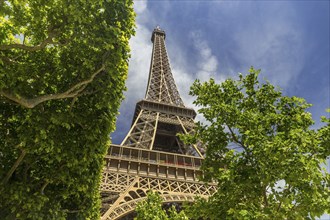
0 64 105 108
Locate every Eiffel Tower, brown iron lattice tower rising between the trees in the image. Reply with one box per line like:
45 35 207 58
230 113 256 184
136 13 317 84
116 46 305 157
101 27 216 220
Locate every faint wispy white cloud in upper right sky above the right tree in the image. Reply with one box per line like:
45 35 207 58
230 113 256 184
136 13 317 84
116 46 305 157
229 4 305 89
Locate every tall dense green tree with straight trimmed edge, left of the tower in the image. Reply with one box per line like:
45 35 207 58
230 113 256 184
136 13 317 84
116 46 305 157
0 0 135 219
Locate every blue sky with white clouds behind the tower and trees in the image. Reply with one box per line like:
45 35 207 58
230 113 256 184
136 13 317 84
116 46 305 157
111 0 330 144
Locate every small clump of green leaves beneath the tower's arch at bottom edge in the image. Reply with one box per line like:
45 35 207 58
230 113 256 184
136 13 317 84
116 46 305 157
135 191 188 220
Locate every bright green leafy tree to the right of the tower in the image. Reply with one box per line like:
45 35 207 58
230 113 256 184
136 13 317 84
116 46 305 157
186 68 330 219
